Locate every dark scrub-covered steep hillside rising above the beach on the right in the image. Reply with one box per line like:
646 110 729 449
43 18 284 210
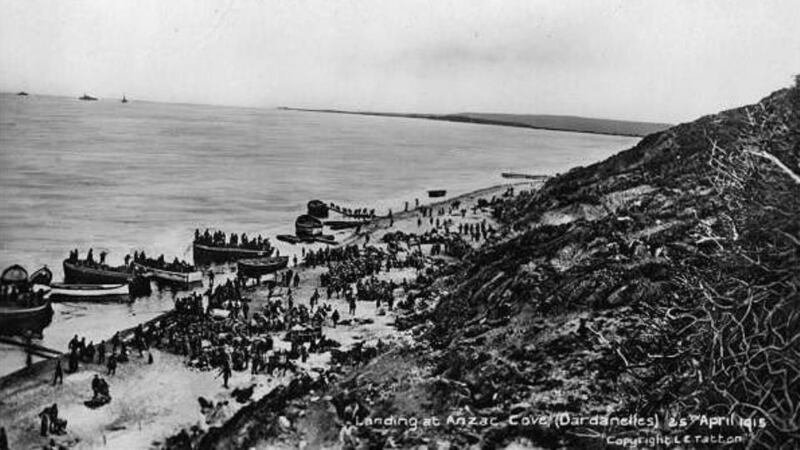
206 86 800 448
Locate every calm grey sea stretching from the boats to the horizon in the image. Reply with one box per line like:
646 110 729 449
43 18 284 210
0 94 638 376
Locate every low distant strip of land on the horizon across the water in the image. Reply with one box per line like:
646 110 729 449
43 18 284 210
279 107 670 136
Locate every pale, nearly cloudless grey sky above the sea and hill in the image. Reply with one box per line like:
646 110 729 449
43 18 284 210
0 0 800 123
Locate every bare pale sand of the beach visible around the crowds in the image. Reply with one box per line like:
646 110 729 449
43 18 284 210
0 181 540 447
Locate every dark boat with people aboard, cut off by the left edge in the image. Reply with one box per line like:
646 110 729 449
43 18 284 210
0 265 53 336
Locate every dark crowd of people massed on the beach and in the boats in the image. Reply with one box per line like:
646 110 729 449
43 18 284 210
7 188 506 450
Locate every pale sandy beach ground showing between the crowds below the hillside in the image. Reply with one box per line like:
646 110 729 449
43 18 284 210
0 183 535 448
